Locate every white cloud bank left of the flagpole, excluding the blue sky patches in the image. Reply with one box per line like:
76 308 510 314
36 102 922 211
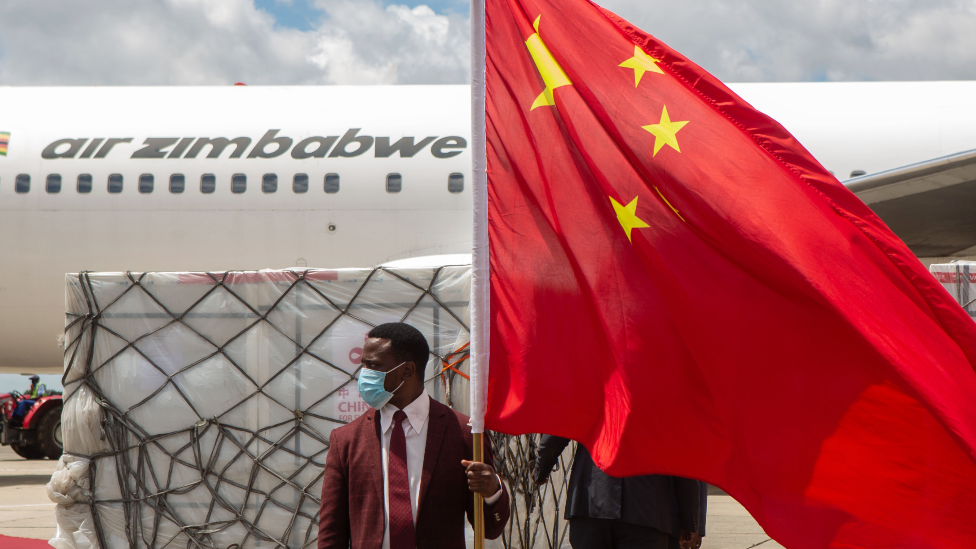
0 0 468 85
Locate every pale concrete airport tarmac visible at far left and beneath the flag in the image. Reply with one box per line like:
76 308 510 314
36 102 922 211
0 446 781 549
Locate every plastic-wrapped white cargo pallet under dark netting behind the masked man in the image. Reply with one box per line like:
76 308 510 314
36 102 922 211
49 266 572 549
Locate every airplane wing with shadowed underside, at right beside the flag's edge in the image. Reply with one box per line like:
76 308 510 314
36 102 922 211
844 150 976 257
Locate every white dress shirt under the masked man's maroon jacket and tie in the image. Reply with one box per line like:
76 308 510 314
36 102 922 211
380 390 502 549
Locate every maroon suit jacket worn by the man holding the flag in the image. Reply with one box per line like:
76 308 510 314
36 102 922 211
318 399 509 549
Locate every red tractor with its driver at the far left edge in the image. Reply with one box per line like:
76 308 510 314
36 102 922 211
0 376 62 459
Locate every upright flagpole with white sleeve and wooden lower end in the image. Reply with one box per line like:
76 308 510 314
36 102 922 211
468 0 491 549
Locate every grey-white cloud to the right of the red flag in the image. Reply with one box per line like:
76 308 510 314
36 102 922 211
603 0 976 82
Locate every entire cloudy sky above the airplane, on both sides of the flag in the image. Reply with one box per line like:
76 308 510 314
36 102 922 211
0 0 976 85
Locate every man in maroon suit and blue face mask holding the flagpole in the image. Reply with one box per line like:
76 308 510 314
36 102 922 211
318 323 509 549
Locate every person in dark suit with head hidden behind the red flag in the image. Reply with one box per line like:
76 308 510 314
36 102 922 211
533 435 707 549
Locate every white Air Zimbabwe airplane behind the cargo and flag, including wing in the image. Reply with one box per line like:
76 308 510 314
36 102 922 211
0 82 976 373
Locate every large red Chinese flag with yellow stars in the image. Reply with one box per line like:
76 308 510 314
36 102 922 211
485 0 976 548
